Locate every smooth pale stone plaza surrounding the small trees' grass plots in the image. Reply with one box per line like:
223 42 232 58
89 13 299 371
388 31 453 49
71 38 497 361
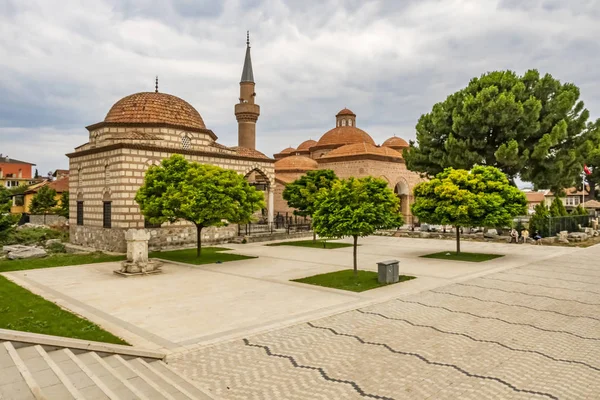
4 236 577 352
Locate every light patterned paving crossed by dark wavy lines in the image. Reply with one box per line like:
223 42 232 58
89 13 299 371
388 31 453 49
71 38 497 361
170 248 600 400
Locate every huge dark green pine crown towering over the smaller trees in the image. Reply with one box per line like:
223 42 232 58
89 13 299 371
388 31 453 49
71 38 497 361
404 70 589 191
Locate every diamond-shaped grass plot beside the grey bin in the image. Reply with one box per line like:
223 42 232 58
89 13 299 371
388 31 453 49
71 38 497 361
293 269 415 292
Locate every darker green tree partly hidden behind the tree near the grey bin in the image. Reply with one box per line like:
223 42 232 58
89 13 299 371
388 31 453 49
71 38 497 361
283 169 338 241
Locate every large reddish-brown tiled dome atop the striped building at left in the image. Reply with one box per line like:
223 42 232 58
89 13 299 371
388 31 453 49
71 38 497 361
104 92 206 129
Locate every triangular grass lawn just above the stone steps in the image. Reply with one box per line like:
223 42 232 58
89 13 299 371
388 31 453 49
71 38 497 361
0 276 128 344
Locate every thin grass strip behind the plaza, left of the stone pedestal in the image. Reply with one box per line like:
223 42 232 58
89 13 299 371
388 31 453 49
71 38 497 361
0 252 125 272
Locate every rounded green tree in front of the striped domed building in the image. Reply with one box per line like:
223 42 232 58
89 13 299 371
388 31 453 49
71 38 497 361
135 155 265 257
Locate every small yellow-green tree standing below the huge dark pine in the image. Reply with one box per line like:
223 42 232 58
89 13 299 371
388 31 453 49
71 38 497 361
411 166 527 253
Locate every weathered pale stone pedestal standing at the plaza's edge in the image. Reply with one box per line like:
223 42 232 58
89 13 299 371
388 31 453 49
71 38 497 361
115 229 162 276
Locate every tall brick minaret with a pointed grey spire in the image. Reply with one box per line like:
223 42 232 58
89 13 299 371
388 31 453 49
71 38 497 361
235 32 260 149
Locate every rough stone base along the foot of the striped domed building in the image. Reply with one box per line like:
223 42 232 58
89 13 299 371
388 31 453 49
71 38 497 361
70 224 238 253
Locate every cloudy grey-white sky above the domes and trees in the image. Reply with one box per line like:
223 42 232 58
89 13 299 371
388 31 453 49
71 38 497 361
0 0 600 177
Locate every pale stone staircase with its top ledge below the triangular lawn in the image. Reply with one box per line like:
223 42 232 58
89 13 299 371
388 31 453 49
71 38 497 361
0 330 213 400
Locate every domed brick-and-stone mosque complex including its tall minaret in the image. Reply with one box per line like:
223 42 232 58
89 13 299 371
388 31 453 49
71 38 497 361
67 33 420 251
